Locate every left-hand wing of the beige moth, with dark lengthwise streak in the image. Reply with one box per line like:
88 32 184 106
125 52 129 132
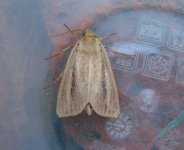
56 44 87 117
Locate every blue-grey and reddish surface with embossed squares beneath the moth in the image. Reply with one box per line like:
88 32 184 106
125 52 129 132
0 0 184 150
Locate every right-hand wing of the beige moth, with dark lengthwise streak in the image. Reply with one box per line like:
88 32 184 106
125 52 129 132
91 44 120 117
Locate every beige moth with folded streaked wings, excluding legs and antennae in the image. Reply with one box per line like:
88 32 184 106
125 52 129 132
56 29 120 117
